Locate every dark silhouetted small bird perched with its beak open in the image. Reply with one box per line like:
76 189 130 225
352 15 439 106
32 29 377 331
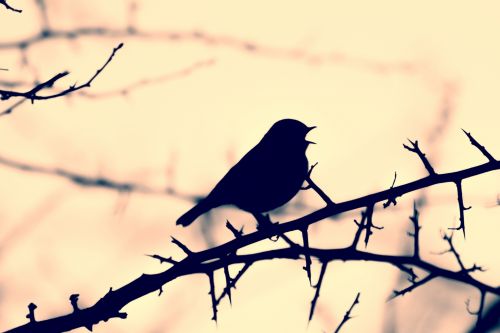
176 119 316 227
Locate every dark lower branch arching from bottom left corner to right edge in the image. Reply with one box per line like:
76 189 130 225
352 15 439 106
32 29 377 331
7 243 500 333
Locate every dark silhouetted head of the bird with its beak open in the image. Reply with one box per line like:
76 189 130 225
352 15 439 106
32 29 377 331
266 119 316 150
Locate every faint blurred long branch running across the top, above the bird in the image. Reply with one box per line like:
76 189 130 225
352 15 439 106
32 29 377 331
0 25 426 75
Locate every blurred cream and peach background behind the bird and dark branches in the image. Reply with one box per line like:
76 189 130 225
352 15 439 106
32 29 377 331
0 0 500 333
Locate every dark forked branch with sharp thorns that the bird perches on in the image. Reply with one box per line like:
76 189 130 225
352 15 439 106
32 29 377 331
4 133 500 333
